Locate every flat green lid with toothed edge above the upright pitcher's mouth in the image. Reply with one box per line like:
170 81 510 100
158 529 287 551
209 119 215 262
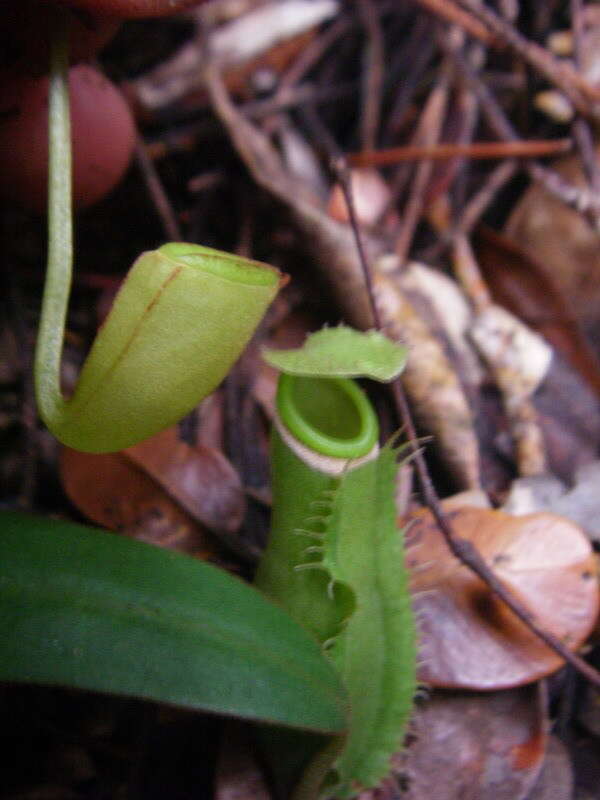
263 325 406 382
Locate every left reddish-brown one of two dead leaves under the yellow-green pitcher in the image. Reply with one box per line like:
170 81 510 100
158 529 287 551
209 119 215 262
60 447 215 559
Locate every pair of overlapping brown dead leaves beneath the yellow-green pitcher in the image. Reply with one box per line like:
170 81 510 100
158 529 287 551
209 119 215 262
61 428 246 558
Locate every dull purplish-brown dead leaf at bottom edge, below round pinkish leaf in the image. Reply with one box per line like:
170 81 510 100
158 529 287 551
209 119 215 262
396 686 547 800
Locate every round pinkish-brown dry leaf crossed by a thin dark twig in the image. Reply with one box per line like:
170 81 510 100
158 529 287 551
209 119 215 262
408 508 598 690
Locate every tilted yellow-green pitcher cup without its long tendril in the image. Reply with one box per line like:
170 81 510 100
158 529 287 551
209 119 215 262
40 243 281 453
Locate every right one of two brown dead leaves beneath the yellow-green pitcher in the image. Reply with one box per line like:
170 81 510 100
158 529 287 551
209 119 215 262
124 428 246 533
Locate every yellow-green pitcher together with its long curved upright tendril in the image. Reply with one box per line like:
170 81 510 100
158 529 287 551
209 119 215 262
35 14 285 453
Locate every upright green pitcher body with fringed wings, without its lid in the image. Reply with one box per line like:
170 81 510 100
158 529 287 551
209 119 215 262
256 376 416 798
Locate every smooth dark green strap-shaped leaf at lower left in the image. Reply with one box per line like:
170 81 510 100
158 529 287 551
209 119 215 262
0 512 346 732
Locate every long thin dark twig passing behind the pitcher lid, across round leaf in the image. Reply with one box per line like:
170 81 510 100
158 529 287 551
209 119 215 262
332 156 600 687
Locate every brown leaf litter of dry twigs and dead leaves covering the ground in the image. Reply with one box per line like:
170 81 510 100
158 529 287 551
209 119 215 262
0 0 600 800
